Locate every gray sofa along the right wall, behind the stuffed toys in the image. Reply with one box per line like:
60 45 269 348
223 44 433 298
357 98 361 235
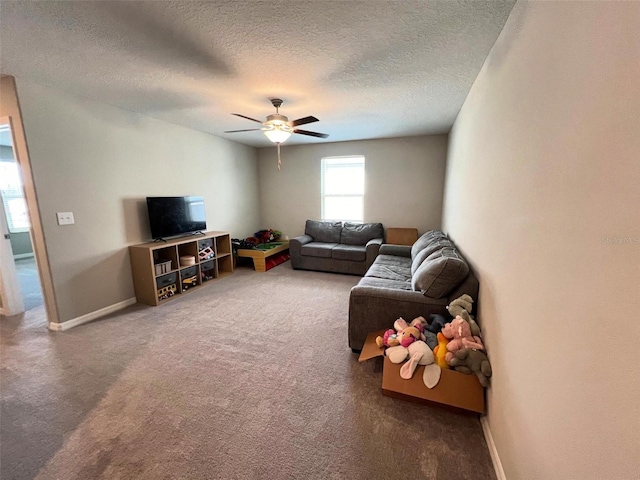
349 230 479 352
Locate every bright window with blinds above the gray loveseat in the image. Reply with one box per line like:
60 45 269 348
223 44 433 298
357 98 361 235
322 156 364 222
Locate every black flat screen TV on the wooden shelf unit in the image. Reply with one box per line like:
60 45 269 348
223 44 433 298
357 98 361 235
147 197 207 239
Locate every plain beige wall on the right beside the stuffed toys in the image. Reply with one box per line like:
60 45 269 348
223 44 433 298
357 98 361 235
444 2 640 479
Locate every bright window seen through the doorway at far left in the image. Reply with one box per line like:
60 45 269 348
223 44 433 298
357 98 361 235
0 161 31 233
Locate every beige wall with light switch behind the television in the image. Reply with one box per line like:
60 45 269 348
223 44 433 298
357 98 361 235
16 78 259 322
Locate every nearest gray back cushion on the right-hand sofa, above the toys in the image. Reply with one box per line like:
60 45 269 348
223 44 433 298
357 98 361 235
411 247 469 298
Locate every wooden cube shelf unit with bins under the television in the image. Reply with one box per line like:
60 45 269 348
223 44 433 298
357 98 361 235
129 232 233 306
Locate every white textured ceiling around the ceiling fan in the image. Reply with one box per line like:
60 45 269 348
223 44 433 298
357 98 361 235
0 0 515 147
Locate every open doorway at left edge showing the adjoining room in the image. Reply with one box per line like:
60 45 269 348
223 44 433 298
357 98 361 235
0 119 44 316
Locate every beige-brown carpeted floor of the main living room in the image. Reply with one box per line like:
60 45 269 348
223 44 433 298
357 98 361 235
0 262 495 480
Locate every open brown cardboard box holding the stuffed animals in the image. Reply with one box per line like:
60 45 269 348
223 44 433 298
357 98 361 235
358 331 485 413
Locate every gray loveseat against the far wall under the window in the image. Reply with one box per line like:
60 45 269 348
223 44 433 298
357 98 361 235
289 220 384 275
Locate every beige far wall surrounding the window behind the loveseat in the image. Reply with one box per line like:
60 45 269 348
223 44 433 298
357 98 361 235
258 135 447 237
